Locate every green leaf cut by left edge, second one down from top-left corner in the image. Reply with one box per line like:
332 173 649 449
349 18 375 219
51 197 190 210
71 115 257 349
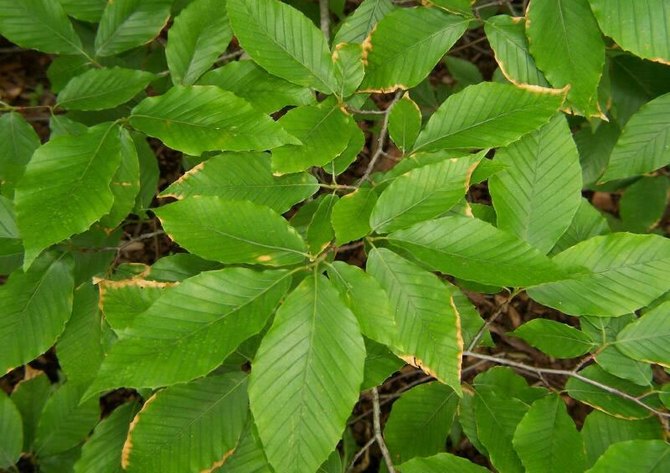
0 112 40 197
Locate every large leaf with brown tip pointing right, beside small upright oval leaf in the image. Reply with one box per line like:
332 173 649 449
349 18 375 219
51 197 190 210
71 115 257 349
414 82 565 151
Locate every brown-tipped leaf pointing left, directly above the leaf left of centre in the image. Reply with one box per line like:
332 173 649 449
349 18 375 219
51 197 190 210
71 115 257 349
161 153 319 213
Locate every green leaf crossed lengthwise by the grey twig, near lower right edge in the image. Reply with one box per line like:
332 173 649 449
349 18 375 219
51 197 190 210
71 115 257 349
565 365 654 419
